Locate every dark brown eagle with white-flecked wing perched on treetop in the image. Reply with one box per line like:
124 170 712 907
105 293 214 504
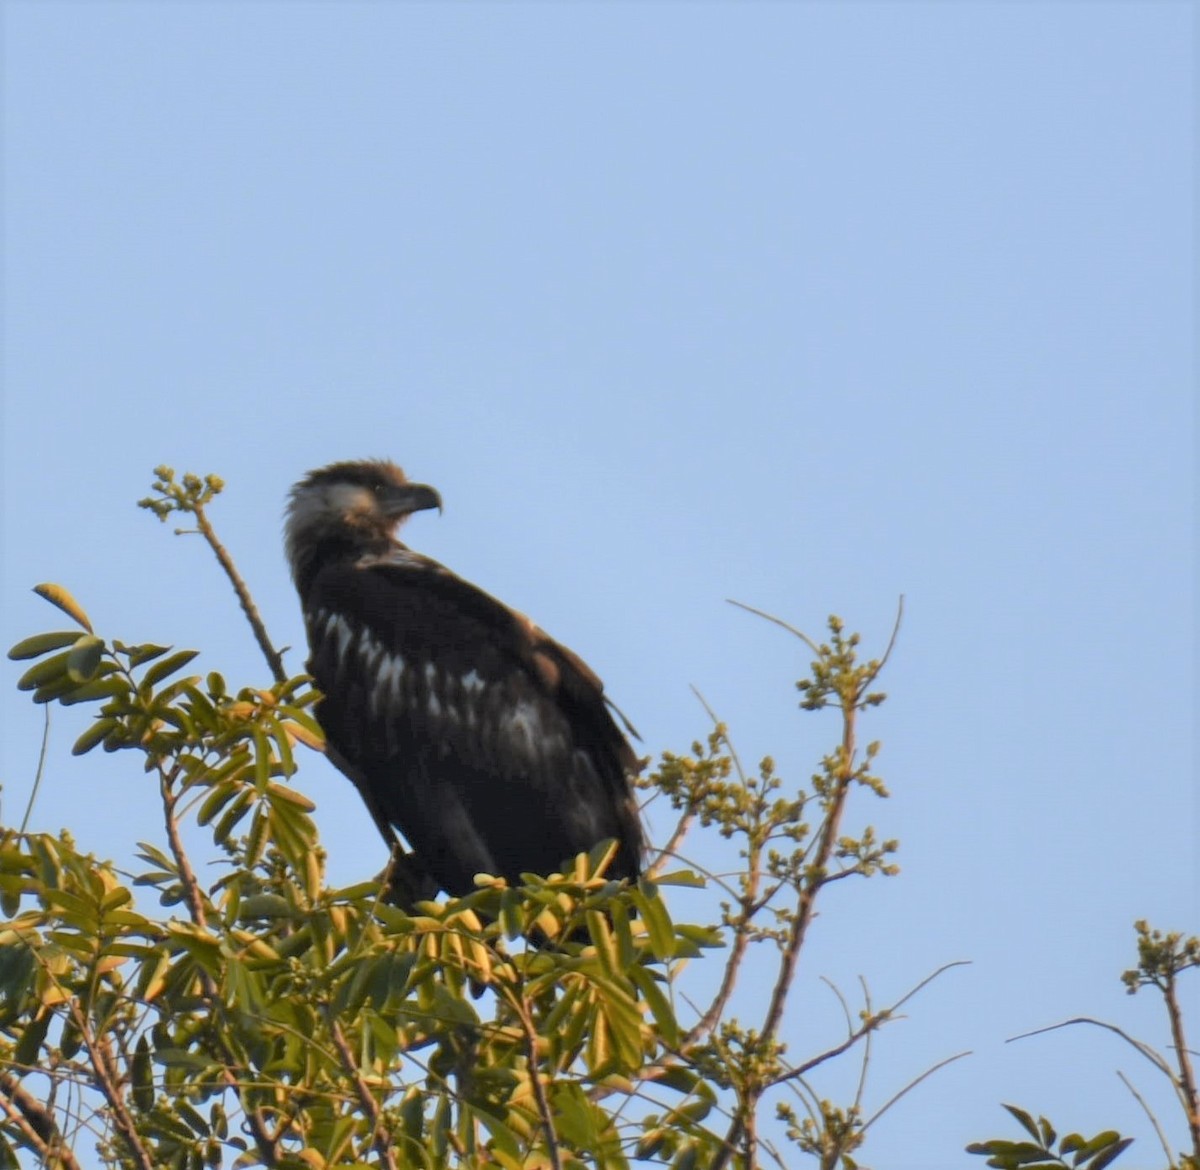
286 461 643 894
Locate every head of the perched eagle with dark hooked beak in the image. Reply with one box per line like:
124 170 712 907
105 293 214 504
284 460 442 583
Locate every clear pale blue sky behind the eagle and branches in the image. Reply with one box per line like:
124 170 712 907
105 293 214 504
0 0 1200 1170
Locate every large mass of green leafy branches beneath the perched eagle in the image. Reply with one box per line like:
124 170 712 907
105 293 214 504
0 468 945 1170
